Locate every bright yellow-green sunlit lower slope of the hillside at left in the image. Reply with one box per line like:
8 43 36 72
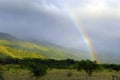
0 40 45 59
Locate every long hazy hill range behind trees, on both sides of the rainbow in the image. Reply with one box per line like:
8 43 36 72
0 33 120 63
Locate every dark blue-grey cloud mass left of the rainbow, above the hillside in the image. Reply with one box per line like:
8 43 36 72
0 0 82 46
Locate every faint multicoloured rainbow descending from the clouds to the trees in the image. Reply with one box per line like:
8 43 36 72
61 1 100 63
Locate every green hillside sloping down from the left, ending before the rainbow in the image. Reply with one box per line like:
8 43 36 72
0 33 78 59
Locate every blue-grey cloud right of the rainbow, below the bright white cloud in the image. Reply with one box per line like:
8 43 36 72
83 18 120 53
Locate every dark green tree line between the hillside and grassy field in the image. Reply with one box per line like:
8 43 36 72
0 58 120 77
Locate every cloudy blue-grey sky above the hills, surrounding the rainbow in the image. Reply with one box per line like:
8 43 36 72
0 0 120 60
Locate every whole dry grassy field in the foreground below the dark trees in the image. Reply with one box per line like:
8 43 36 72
0 65 120 80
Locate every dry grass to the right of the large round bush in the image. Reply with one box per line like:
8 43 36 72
42 69 120 80
